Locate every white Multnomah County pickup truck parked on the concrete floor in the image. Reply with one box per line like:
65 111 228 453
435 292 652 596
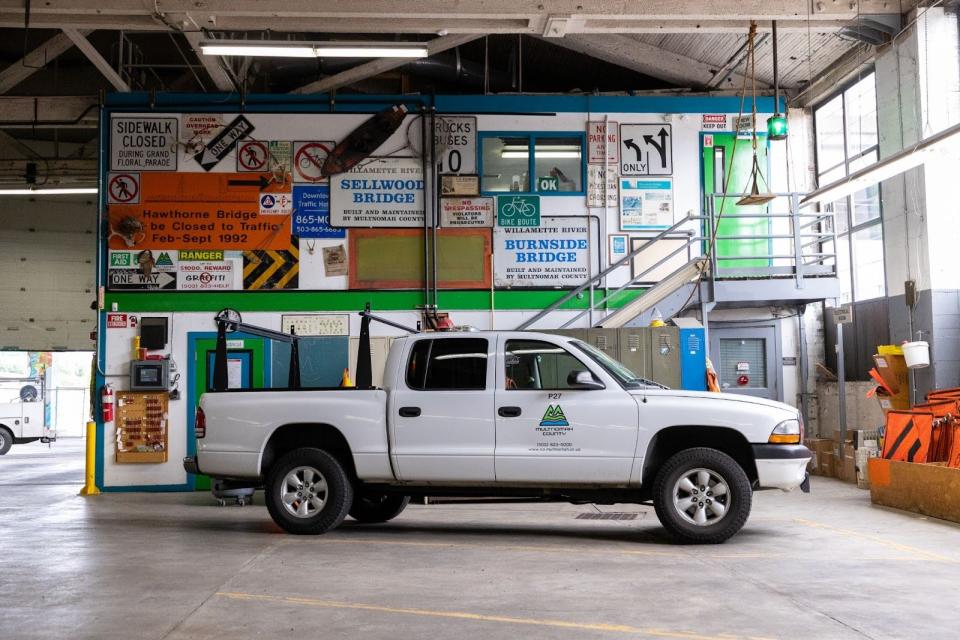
184 331 811 543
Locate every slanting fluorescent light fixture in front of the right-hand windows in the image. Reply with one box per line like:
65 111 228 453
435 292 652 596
800 124 960 207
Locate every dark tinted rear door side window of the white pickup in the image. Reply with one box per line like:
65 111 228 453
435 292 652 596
407 338 487 391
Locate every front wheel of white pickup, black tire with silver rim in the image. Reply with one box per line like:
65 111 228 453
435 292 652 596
653 447 753 544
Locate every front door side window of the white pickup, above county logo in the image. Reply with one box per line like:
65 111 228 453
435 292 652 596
504 340 589 390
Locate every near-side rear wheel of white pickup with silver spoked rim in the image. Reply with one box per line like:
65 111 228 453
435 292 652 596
266 447 353 535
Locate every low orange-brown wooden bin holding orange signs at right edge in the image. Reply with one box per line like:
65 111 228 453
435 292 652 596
867 458 960 522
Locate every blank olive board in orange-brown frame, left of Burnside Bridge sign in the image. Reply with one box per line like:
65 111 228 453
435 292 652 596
349 229 491 289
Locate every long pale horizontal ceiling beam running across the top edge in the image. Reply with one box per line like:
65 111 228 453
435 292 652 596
0 0 916 35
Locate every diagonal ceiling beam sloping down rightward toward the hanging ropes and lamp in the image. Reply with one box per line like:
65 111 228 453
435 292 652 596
547 34 767 89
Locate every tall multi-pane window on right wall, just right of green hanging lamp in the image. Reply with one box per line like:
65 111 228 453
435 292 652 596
813 73 886 302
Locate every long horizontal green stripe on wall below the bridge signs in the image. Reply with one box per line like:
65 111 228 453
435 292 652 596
106 289 643 312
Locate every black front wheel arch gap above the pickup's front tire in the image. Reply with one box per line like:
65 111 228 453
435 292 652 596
641 425 757 490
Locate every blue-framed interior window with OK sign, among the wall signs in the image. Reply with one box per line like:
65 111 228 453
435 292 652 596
480 131 586 196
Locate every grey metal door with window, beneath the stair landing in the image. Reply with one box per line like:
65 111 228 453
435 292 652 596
710 325 783 400
